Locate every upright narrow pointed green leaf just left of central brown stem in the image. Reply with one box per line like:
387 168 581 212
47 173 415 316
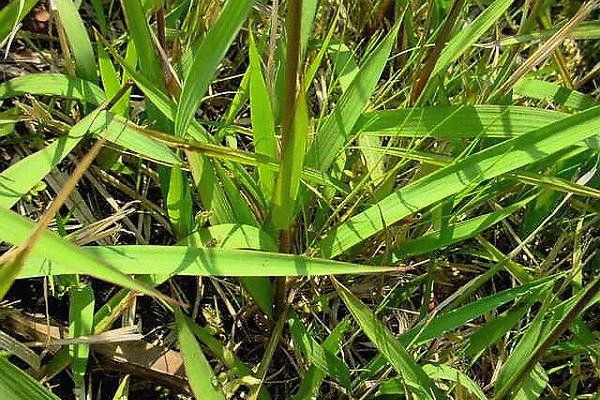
248 33 277 201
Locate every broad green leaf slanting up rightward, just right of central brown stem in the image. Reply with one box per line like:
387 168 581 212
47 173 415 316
306 25 399 171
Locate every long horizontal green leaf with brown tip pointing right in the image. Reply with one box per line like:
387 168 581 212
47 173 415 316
21 244 397 278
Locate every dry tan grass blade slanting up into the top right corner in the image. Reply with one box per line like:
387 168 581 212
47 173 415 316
492 0 600 98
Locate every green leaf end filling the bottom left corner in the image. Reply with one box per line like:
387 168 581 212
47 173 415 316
0 357 60 400
